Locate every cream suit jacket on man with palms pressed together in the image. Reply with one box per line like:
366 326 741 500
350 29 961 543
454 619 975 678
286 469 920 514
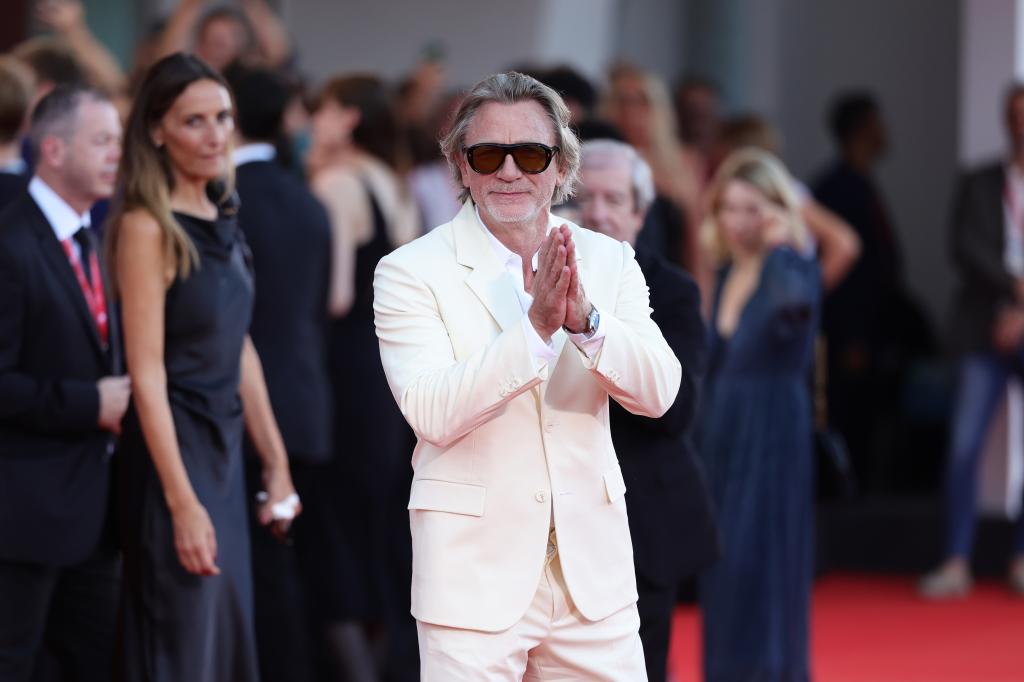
374 201 681 632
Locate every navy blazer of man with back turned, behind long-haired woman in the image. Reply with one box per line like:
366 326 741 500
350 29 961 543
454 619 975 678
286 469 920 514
237 161 332 462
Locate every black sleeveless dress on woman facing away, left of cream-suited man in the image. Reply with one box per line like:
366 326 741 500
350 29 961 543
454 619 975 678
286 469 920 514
321 188 412 622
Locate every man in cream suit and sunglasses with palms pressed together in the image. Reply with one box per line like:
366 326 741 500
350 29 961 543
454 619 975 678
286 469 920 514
374 73 681 682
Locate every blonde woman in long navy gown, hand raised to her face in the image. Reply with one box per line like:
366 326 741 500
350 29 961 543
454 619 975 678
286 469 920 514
699 150 820 682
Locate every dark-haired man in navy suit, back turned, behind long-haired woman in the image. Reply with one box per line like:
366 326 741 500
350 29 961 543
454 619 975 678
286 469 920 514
227 65 332 682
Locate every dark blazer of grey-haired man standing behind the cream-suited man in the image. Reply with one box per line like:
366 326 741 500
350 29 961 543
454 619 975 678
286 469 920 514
611 249 718 586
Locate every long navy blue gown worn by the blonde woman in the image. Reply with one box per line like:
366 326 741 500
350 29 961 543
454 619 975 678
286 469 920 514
698 248 821 682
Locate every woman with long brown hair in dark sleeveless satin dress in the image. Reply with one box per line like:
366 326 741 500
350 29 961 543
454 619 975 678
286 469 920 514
108 54 298 682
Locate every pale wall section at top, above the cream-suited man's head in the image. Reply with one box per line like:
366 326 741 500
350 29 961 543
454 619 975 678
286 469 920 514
283 0 617 85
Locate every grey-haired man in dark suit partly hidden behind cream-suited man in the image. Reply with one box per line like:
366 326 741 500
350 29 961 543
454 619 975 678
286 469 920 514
579 140 718 682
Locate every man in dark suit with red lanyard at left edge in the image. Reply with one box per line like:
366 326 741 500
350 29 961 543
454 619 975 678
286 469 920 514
0 87 129 681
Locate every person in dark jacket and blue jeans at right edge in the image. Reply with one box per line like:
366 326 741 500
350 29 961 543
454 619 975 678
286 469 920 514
920 84 1024 599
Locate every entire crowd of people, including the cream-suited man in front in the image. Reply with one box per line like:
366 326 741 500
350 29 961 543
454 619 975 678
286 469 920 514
0 0 1024 682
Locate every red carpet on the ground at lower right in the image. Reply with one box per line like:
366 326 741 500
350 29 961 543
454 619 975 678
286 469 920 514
669 576 1024 682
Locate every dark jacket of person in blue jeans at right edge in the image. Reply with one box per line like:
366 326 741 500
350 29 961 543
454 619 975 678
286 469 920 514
950 163 1015 352
